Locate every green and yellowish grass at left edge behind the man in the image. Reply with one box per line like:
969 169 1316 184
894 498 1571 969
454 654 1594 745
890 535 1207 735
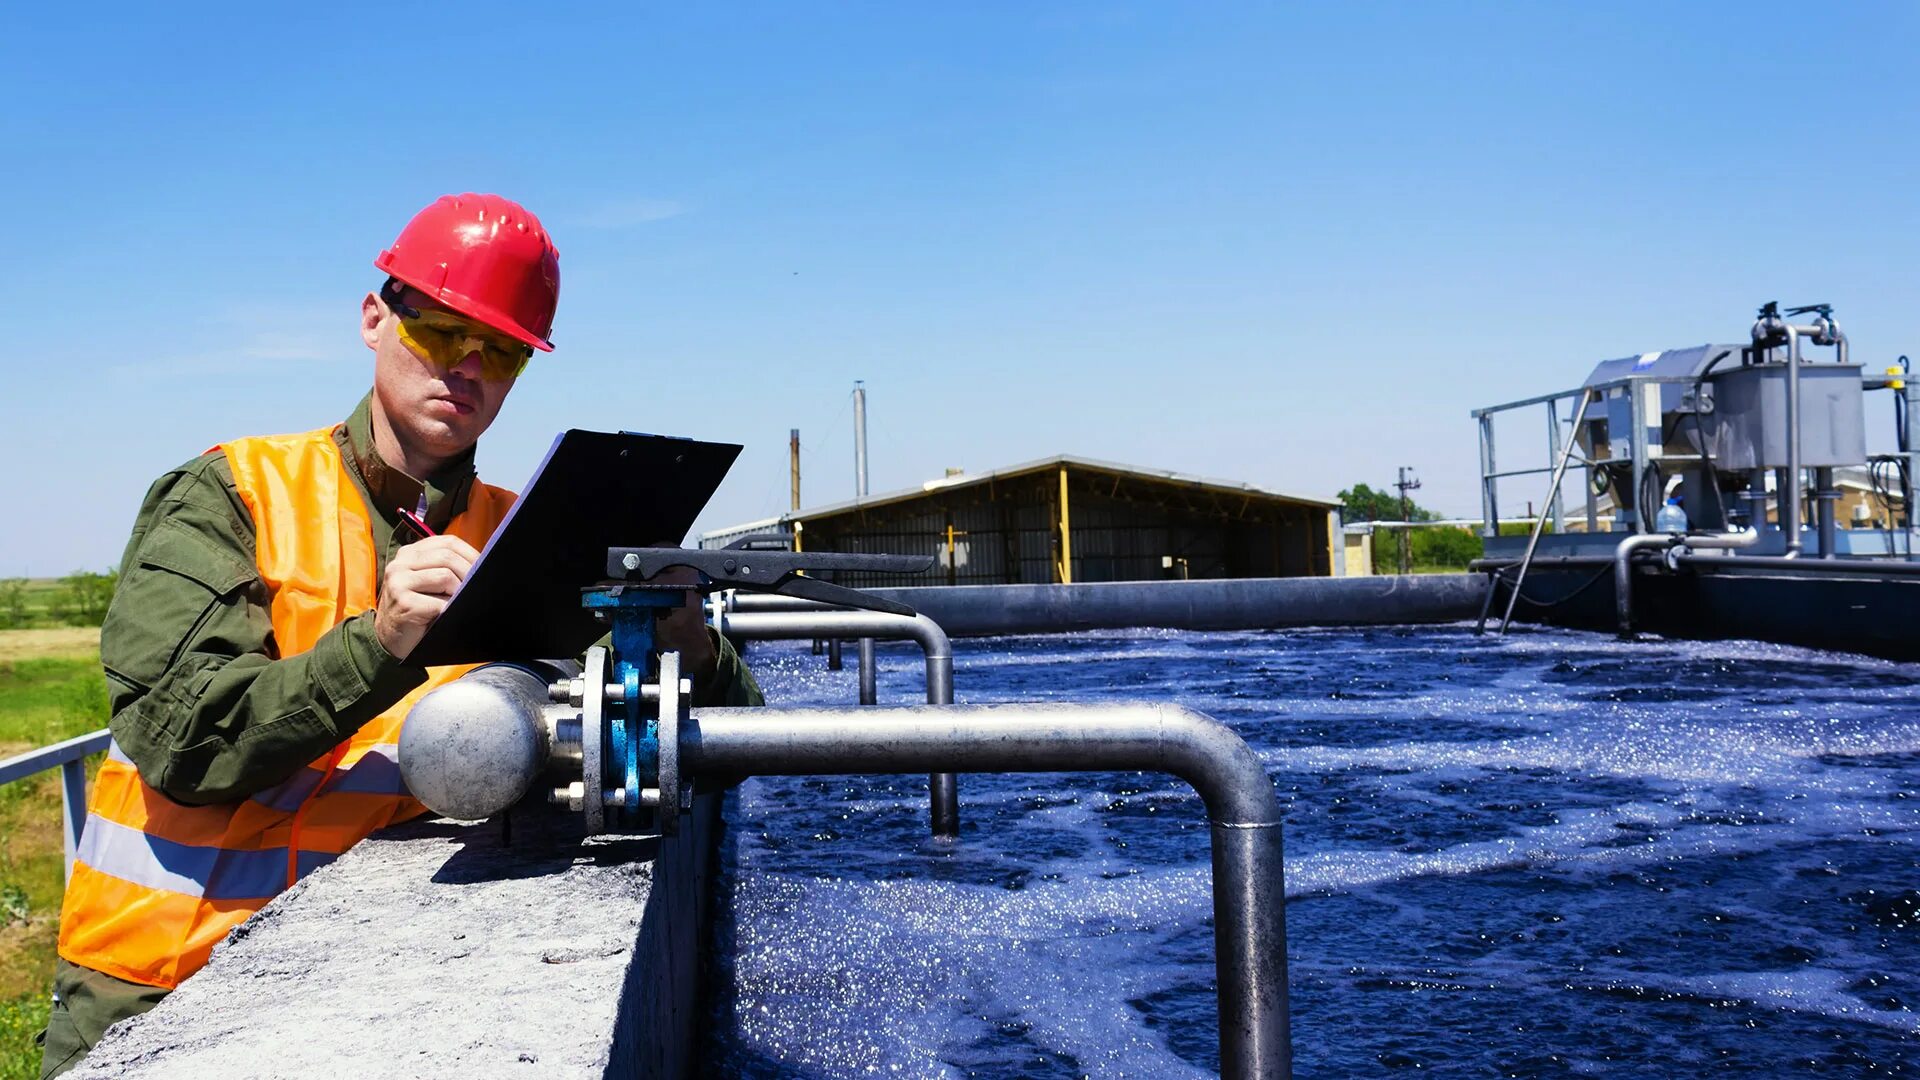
0 632 108 1080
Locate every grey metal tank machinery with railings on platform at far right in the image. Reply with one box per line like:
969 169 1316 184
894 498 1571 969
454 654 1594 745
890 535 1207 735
1473 304 1920 655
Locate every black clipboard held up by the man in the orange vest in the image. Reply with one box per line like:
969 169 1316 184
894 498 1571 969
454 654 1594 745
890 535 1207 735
407 430 741 667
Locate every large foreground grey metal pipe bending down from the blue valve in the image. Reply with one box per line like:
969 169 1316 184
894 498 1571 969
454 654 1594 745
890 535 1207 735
680 705 1292 1078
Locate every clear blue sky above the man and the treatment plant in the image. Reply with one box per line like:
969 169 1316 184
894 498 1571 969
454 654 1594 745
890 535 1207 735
0 2 1920 577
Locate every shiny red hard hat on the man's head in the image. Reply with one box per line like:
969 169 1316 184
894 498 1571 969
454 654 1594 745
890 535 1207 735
372 194 561 352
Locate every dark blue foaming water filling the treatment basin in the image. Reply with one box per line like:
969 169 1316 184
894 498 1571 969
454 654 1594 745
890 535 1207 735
710 626 1920 1076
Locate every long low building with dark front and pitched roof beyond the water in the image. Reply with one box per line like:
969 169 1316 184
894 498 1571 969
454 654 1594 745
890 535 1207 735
701 455 1344 588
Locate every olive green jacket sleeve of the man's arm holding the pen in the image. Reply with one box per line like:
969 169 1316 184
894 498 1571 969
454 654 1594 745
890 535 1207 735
100 452 426 803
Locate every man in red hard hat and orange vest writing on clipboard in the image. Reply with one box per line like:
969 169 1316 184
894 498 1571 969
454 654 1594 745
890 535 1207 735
40 194 760 1078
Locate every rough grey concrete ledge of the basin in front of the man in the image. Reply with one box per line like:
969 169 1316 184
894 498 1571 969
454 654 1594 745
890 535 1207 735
71 796 720 1080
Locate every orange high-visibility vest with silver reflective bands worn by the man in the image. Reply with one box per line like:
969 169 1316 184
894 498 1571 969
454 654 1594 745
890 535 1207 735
60 429 515 990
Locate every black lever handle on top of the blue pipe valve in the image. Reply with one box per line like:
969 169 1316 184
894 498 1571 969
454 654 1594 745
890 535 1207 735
607 536 933 619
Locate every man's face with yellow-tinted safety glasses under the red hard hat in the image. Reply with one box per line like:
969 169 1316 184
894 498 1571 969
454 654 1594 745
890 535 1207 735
361 288 513 461
